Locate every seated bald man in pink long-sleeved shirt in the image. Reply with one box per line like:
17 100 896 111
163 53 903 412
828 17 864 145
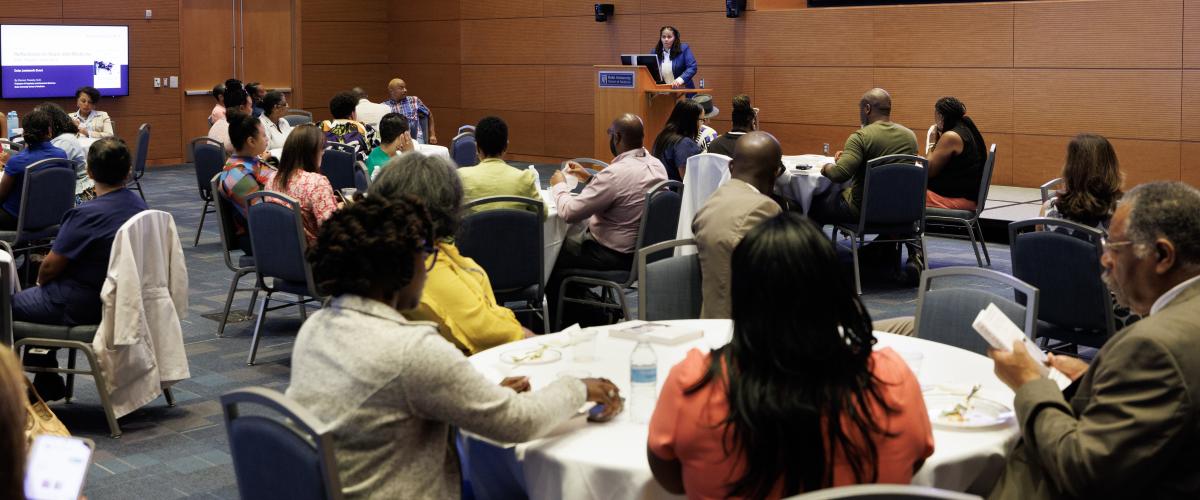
546 112 672 325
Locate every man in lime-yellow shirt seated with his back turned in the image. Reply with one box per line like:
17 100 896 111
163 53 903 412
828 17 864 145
458 116 541 213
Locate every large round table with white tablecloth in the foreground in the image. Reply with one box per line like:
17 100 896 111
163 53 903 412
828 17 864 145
463 320 1019 499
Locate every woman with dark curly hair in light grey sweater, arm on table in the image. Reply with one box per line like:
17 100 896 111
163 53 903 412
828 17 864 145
287 197 622 499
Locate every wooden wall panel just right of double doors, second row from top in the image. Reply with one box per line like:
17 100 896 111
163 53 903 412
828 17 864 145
300 20 390 65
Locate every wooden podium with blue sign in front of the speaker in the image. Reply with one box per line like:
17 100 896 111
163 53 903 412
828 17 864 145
592 65 713 162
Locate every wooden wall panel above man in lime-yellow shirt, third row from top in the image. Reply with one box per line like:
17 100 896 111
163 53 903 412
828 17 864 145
462 65 546 112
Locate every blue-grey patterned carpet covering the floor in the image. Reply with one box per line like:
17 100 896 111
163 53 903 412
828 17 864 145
39 165 1010 500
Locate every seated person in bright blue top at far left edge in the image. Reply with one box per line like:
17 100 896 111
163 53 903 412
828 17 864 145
0 109 67 231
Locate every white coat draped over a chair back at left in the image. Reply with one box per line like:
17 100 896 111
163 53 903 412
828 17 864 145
91 210 191 417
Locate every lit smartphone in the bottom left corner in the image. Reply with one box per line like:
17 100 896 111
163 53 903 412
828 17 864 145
25 435 96 500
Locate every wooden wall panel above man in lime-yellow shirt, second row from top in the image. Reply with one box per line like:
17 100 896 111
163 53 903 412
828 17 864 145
462 18 547 65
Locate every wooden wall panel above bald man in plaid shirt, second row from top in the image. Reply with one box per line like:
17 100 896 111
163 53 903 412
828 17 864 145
385 20 462 65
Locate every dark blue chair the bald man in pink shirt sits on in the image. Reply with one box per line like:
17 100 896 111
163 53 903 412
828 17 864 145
554 181 684 327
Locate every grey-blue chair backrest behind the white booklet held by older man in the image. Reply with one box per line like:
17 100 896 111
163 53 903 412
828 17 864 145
914 266 1038 355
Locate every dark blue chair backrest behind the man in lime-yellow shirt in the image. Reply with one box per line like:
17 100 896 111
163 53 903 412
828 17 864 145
455 197 546 297
